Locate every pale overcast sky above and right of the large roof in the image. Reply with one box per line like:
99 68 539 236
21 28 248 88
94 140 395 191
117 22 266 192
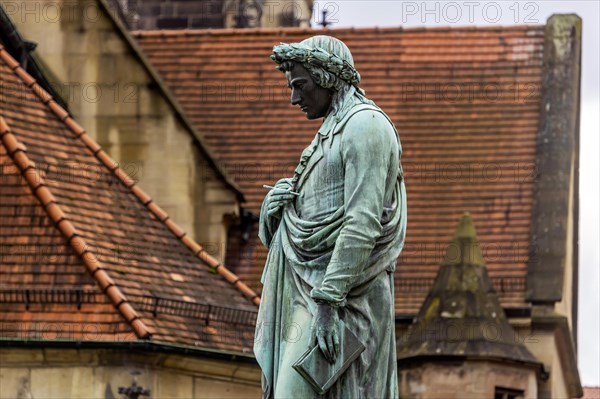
312 0 600 386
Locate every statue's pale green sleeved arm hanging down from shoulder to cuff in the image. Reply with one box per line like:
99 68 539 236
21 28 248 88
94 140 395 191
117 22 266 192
311 110 399 305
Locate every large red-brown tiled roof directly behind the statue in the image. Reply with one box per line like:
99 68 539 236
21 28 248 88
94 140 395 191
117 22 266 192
134 26 544 314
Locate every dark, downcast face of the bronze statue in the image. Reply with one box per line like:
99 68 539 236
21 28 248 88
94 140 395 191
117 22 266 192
285 64 331 119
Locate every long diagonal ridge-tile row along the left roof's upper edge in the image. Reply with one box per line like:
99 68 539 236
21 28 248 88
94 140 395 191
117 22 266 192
0 45 260 306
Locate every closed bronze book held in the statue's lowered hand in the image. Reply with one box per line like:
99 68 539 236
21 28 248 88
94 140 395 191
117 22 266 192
292 320 365 395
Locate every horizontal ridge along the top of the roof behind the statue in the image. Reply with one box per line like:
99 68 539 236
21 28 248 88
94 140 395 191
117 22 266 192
130 24 544 37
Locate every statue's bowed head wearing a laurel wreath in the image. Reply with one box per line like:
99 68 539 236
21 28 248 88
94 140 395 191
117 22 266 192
271 36 360 119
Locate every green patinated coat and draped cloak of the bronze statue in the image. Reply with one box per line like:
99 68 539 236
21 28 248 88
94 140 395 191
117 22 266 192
254 95 406 398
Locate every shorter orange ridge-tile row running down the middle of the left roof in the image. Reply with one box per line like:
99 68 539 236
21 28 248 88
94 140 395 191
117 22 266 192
0 115 152 339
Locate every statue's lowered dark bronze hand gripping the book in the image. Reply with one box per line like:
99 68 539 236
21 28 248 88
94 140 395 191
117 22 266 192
311 303 340 363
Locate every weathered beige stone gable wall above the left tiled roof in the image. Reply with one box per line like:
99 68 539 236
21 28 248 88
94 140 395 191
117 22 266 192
2 0 239 261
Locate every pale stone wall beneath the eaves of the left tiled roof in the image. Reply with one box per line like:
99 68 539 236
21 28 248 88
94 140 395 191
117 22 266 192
0 348 261 399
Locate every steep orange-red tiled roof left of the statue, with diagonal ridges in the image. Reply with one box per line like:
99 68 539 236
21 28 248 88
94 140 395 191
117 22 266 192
0 45 259 352
